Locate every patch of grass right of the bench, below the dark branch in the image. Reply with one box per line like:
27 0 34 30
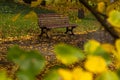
76 14 101 32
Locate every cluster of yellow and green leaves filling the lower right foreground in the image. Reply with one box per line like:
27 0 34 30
44 39 120 80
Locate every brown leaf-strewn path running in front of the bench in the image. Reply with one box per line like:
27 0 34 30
0 31 114 61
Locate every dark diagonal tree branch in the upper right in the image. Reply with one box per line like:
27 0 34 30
79 0 119 39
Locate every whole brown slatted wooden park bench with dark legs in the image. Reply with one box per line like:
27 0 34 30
38 13 77 37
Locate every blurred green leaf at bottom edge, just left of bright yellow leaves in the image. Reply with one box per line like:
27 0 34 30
44 70 60 80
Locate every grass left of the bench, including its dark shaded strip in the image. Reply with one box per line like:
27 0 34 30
0 3 53 38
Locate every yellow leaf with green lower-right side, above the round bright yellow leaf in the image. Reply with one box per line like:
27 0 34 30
84 40 111 64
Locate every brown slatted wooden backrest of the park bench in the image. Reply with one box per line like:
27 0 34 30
38 13 69 27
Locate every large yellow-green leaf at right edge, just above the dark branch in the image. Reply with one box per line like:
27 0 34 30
107 10 120 28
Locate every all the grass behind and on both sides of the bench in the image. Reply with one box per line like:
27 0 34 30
0 2 100 38
